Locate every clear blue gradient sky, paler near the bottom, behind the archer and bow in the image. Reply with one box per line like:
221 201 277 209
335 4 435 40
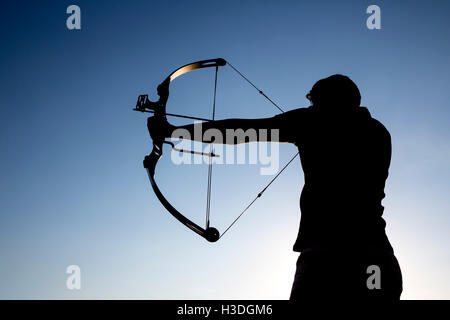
0 0 450 299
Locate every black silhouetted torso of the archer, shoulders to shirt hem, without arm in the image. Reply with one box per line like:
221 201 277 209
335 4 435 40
281 107 392 251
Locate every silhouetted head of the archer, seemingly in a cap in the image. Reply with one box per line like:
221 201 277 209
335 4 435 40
306 74 361 112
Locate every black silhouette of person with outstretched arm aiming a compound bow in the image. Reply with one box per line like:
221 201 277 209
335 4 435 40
149 74 402 300
